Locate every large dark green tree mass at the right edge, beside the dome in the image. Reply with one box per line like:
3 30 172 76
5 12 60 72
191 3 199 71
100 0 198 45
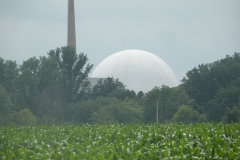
182 53 240 122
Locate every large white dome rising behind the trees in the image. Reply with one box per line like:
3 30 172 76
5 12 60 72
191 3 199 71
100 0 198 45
91 50 178 92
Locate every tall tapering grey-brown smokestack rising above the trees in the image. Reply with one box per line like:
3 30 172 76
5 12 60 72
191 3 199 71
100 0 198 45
67 0 76 51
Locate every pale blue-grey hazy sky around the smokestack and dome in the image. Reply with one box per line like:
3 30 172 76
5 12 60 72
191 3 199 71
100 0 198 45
0 0 240 82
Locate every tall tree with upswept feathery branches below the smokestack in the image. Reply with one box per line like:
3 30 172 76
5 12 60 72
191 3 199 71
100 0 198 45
44 46 93 102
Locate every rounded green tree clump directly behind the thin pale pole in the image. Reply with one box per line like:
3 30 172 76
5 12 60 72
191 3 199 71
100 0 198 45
143 85 194 123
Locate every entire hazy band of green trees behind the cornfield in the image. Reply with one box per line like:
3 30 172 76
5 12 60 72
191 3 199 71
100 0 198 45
0 47 240 125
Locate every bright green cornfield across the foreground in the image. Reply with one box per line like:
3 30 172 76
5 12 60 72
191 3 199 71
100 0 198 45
0 124 240 160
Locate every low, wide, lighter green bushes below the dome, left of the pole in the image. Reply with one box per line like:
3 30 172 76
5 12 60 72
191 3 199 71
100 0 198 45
68 97 143 124
